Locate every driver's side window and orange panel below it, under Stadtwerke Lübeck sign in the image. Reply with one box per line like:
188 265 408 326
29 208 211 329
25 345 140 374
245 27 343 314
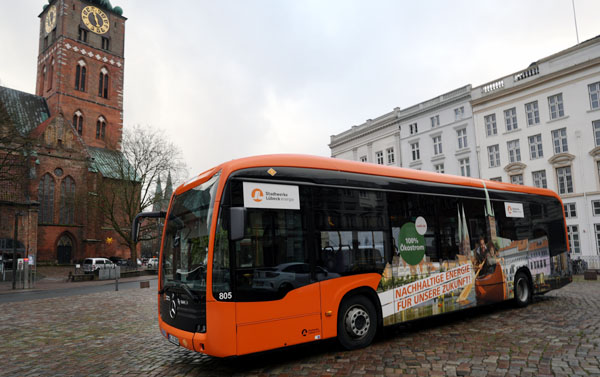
234 204 321 354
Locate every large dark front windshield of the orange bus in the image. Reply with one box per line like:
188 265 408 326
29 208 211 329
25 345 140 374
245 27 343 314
161 173 219 294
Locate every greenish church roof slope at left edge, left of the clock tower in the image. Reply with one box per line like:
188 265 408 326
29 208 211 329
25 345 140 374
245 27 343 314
0 86 50 136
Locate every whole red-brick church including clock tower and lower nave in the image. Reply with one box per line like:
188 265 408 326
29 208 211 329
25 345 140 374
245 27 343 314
0 0 130 264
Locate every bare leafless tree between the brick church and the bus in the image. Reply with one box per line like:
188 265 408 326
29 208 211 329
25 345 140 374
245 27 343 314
95 125 185 263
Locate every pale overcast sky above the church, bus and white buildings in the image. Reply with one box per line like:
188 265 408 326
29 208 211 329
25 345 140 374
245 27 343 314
0 0 600 181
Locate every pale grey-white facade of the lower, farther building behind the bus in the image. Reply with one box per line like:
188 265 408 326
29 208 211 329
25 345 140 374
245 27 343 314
329 85 479 177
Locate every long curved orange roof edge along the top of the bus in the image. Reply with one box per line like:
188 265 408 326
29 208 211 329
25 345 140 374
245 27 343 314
174 154 560 200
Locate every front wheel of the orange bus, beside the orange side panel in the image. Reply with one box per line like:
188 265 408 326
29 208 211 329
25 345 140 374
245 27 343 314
338 296 377 350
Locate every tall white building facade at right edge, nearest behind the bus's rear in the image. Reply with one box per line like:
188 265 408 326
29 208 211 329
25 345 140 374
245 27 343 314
471 37 600 268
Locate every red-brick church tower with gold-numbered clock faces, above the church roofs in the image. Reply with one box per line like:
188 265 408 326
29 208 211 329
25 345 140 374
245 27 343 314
36 0 127 150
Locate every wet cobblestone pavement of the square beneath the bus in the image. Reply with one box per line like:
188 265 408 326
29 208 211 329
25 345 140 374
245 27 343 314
0 281 600 376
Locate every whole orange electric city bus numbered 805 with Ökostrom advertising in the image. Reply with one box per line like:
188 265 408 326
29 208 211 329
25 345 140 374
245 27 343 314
132 155 572 357
